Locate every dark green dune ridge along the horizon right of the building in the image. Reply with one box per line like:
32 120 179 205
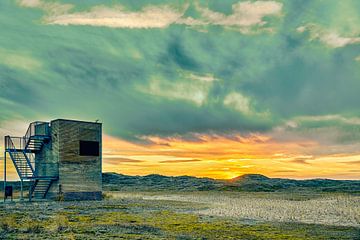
103 173 360 194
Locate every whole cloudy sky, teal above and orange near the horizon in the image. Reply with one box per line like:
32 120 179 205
0 0 360 179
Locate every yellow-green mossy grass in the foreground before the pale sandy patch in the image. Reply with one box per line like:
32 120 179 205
0 193 360 240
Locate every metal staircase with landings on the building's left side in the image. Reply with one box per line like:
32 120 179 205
5 122 58 201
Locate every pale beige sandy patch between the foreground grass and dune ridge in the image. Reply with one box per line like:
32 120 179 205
112 192 360 227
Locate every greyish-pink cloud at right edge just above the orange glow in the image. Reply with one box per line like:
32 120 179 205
269 115 360 157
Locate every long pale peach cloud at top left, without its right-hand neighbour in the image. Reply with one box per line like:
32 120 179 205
19 0 187 28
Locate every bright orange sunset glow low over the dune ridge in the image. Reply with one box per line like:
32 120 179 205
0 134 360 180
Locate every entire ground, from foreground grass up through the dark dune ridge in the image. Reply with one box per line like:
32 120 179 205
0 173 360 240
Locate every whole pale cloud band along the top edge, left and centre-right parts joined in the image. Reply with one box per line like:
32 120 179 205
19 0 282 33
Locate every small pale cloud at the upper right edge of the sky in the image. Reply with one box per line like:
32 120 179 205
296 24 360 48
